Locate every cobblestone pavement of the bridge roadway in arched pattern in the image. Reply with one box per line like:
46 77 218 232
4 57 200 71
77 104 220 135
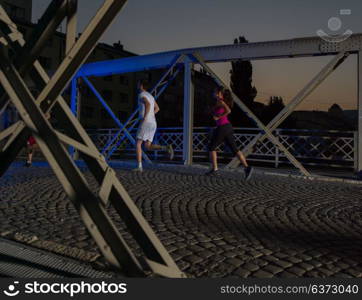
0 163 362 278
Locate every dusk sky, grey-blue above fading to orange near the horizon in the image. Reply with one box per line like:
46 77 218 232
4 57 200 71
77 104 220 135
33 0 362 110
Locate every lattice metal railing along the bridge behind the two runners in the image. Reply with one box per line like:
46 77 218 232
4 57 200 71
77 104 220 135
88 127 357 168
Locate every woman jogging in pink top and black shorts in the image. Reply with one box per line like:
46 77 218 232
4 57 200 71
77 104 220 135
207 87 253 180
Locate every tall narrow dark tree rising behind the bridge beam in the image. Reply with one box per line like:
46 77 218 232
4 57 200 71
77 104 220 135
230 36 257 126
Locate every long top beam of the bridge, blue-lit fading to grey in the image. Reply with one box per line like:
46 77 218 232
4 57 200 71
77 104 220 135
76 34 362 77
